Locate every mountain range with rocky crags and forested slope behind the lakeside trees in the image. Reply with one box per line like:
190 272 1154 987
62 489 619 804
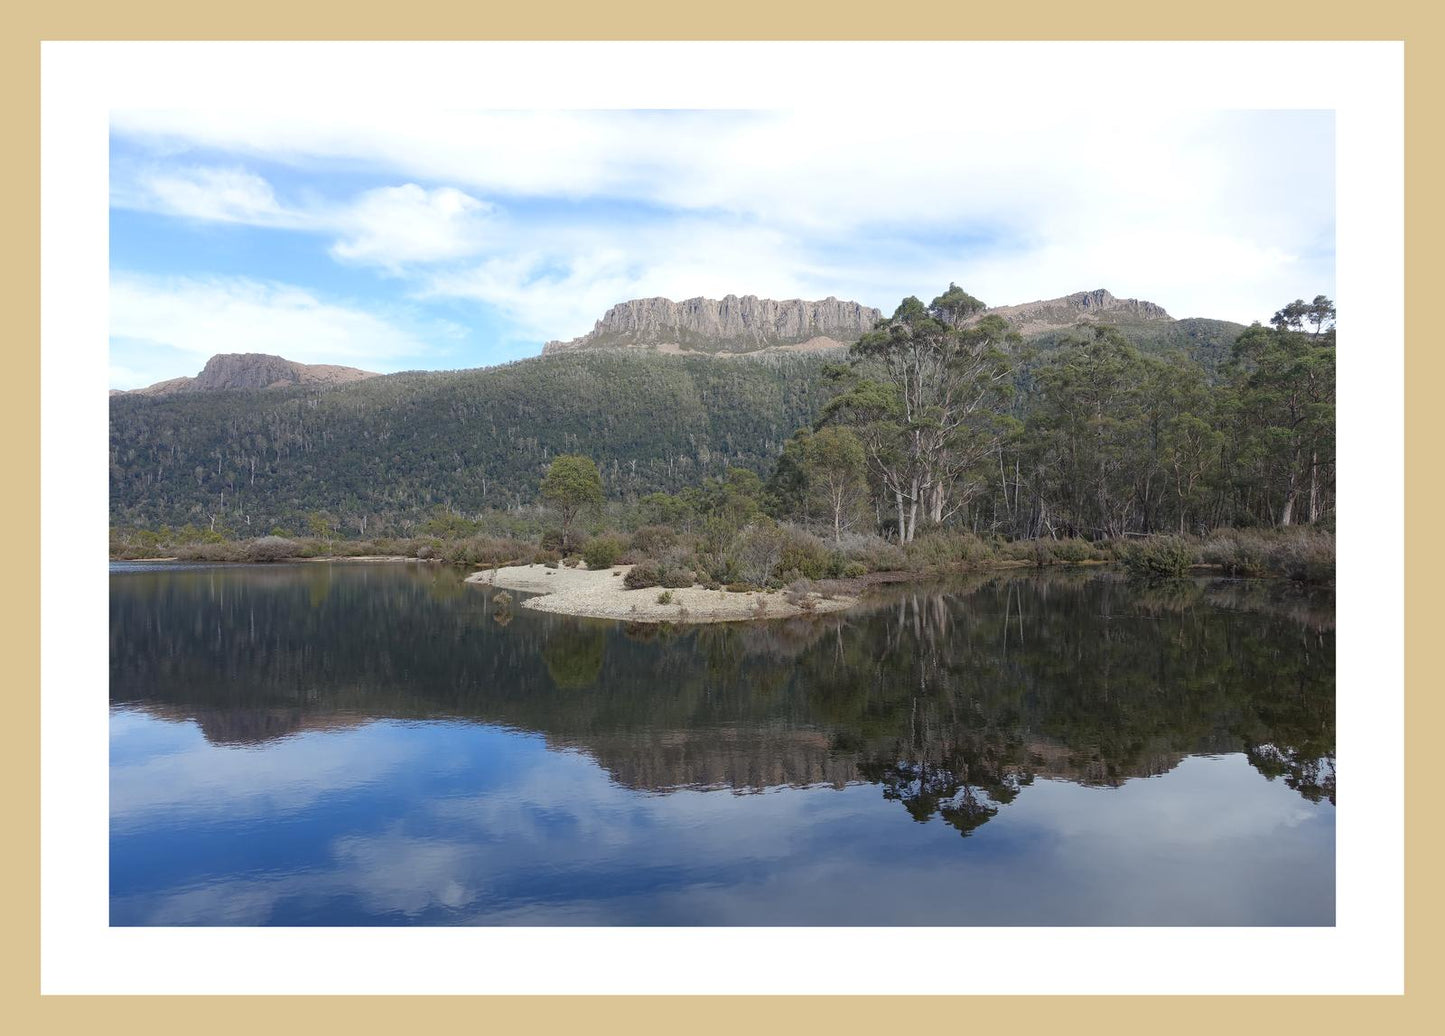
110 284 1243 533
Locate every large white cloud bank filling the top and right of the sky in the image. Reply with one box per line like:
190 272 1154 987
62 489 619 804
113 105 1334 330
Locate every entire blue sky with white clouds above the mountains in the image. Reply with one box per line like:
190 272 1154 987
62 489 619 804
110 107 1335 389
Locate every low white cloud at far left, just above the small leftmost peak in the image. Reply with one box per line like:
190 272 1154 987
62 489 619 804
110 272 439 389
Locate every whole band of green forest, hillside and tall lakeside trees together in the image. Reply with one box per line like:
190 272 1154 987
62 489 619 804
110 278 1335 543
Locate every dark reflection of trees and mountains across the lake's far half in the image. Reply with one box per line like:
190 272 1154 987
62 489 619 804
111 565 1335 835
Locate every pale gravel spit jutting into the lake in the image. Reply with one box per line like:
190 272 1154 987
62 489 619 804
465 565 858 624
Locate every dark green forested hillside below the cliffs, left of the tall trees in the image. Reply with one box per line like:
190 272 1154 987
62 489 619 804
110 351 827 535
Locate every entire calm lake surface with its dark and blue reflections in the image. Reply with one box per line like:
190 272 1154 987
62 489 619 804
110 565 1335 925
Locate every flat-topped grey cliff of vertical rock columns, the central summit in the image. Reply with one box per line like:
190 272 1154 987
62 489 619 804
542 295 883 355
